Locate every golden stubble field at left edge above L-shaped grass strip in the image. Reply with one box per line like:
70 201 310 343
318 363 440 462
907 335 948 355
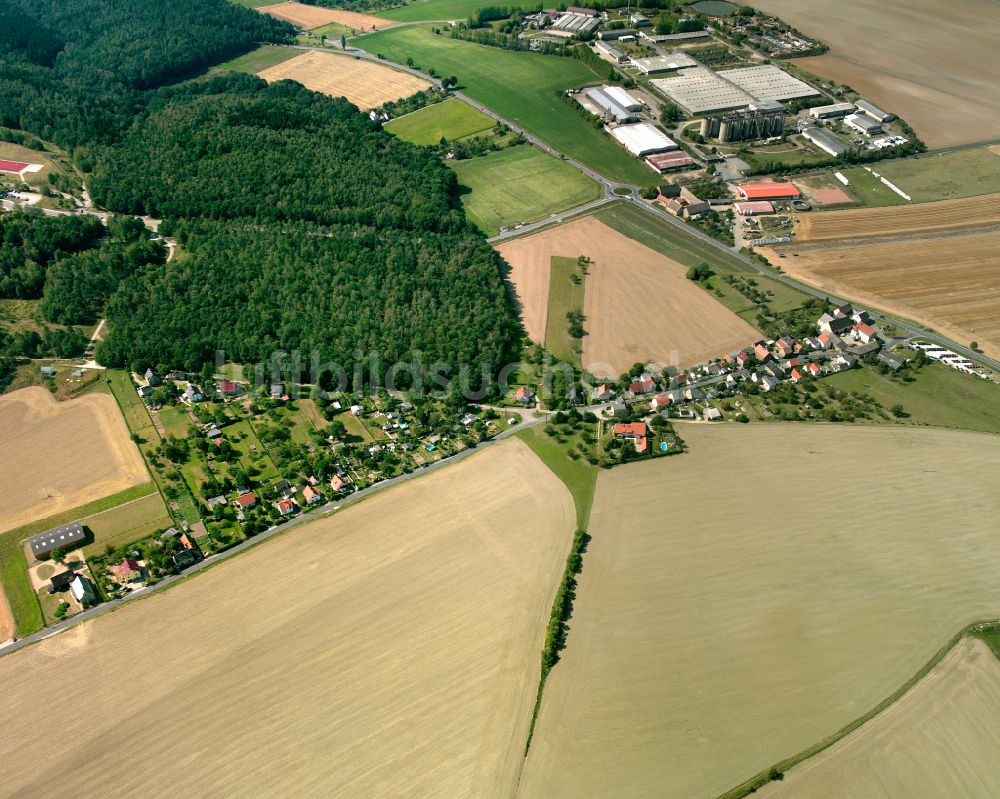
0 386 149 532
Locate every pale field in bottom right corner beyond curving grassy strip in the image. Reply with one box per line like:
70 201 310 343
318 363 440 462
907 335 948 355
756 638 1000 799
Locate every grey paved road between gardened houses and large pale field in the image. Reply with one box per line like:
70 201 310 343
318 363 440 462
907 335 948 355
0 406 552 657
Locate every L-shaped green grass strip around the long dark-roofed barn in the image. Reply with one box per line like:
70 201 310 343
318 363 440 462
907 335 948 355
0 483 159 637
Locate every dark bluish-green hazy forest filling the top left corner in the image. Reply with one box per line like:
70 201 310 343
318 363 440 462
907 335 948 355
0 0 294 148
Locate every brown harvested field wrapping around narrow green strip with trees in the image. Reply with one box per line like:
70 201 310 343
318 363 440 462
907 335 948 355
498 216 759 377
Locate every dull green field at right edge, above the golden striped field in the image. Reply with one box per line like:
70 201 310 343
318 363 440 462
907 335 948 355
872 147 1000 203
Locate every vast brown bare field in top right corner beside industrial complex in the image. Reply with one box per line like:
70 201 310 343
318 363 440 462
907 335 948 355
754 0 1000 147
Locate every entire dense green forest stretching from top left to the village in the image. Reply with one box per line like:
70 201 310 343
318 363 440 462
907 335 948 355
0 0 521 388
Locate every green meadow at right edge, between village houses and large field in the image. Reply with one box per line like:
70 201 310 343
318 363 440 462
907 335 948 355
822 364 1000 433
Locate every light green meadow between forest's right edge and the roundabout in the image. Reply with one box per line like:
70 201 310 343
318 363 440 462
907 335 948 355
449 145 601 235
